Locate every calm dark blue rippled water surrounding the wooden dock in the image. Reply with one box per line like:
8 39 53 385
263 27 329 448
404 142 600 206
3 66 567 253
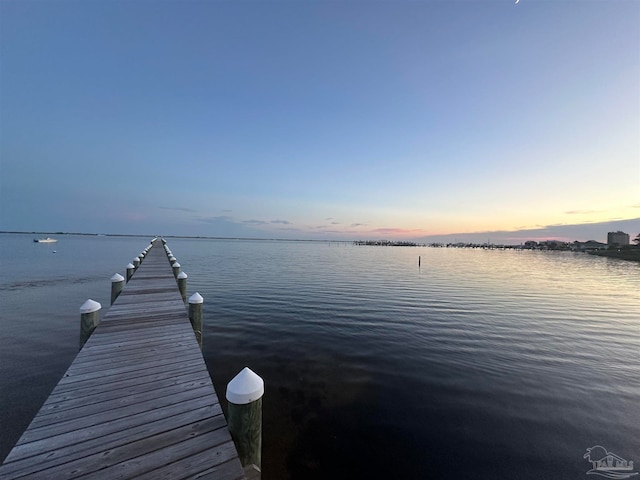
0 235 640 480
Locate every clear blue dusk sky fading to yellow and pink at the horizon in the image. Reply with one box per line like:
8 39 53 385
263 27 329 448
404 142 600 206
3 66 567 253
0 0 640 243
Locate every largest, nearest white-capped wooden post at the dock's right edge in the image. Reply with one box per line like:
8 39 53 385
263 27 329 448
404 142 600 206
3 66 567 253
226 367 264 477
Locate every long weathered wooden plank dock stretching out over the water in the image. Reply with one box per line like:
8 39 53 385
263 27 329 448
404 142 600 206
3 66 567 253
0 240 245 480
